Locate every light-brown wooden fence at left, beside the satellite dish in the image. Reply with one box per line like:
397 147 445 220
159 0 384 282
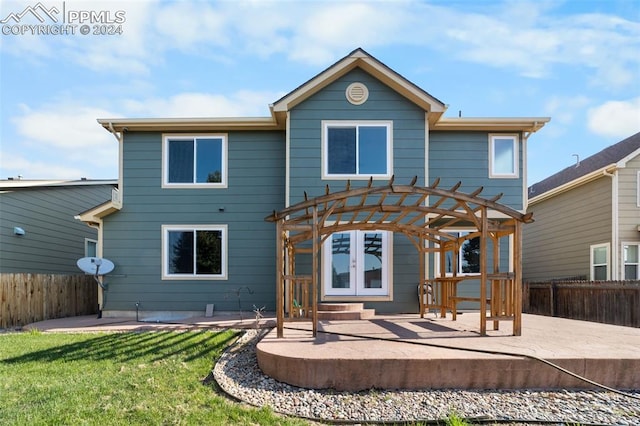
0 274 98 329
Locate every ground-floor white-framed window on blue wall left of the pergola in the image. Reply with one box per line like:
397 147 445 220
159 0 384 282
162 225 227 279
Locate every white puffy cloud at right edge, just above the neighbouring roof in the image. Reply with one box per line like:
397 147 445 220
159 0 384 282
587 97 640 139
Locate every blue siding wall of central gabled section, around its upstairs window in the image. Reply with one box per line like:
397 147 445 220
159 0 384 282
290 69 425 312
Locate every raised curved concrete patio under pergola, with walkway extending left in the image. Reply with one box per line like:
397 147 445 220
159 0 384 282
24 312 640 391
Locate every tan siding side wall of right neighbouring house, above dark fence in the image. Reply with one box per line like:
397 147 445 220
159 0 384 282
522 176 612 282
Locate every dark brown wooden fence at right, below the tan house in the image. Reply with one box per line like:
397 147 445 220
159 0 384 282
523 281 640 327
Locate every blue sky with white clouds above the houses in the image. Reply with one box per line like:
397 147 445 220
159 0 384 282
0 0 640 185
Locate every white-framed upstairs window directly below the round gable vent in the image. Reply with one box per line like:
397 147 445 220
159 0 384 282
322 121 393 179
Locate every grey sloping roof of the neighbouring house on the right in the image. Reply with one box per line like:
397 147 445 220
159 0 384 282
529 133 640 201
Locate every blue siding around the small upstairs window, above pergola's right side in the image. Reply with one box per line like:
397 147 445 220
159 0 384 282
429 131 524 211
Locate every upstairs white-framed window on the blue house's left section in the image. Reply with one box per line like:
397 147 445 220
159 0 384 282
162 135 227 188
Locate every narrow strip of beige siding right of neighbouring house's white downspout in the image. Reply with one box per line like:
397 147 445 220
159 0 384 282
617 156 640 278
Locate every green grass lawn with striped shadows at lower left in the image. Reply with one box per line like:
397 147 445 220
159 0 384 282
0 331 307 425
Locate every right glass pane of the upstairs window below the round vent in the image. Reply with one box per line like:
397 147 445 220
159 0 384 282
358 126 387 175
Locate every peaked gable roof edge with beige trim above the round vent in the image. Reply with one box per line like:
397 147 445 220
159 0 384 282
270 48 447 123
